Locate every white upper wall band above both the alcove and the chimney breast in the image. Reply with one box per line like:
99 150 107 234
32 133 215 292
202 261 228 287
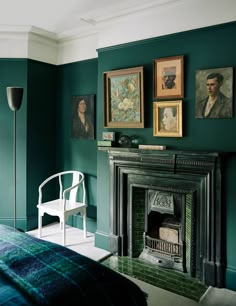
58 0 236 65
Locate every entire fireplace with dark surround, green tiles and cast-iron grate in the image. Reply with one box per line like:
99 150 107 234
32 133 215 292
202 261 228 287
101 148 225 287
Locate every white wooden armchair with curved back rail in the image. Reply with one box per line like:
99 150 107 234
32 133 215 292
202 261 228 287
37 170 87 245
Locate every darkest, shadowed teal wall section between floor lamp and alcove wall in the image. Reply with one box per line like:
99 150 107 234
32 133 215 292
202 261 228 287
26 60 57 229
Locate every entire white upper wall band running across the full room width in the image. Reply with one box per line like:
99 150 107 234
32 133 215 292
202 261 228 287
0 0 236 65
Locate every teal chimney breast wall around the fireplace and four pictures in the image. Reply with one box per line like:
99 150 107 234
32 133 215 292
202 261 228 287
96 23 236 290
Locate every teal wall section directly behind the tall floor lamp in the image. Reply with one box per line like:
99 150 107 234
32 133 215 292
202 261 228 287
0 59 27 227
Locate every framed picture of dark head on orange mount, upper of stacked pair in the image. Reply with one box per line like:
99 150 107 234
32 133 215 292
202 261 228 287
153 55 184 99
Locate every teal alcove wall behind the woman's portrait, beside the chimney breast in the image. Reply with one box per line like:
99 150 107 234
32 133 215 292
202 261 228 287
56 59 100 232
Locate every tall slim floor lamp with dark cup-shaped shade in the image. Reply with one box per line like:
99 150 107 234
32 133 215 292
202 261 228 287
7 87 23 228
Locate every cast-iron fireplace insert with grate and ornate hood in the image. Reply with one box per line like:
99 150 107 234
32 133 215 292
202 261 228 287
138 189 190 272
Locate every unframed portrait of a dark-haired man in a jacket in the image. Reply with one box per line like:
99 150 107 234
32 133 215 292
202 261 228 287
195 67 233 118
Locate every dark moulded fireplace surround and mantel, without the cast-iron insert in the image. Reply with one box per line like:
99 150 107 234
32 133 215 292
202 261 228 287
99 148 226 287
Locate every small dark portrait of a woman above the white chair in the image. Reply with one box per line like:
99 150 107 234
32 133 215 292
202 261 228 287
71 94 95 139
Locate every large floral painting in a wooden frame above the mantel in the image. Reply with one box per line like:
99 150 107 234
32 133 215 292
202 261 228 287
104 67 144 128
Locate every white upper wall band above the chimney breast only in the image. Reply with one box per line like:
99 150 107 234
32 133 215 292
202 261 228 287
98 0 236 48
